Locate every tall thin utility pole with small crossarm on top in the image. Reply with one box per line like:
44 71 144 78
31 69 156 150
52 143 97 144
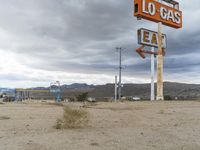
116 47 122 100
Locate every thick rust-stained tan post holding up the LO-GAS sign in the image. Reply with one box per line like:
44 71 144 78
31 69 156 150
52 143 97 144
156 22 164 100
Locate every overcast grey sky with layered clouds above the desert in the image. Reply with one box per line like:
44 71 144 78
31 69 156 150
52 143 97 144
0 0 200 87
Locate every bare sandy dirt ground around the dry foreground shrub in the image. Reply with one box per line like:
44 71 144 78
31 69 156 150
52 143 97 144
0 101 200 150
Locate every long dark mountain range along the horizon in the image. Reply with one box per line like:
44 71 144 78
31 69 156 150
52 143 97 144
0 82 200 100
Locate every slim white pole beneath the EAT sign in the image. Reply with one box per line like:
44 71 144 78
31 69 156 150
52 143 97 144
151 47 155 101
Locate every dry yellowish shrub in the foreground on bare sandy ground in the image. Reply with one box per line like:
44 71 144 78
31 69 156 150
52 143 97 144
55 106 89 129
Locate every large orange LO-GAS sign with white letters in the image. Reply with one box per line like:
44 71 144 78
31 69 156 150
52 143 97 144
134 0 182 28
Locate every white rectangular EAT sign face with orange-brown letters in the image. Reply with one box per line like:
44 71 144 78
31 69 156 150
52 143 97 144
138 28 167 49
